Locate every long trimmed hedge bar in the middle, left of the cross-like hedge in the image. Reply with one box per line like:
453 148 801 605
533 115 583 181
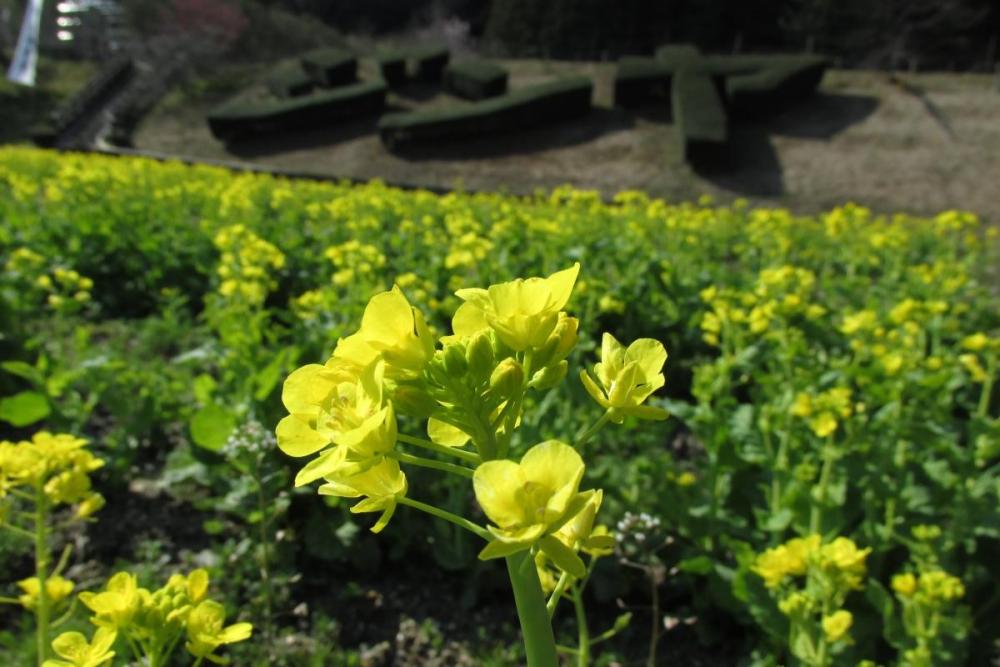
378 77 593 149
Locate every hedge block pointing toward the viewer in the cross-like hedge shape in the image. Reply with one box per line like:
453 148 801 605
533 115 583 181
671 69 728 162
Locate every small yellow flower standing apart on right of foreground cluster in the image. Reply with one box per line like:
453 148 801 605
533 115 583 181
580 333 668 424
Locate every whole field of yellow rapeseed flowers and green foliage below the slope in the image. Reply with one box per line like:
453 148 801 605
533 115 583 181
0 148 1000 667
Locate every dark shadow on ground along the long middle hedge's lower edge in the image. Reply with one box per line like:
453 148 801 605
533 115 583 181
393 107 635 162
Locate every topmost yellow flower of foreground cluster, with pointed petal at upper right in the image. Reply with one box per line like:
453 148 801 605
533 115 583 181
452 263 580 352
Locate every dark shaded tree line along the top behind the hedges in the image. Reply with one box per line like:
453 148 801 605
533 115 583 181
252 0 1000 69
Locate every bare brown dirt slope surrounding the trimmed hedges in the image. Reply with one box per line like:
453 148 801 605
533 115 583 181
135 61 1000 222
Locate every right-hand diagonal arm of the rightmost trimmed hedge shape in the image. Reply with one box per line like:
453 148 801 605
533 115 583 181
725 56 830 117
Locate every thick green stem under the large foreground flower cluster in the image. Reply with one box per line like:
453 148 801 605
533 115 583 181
507 551 558 667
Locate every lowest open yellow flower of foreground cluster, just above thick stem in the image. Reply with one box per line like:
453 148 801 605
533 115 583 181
472 440 593 577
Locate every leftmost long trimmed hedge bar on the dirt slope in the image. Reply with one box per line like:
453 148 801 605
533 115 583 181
208 81 386 141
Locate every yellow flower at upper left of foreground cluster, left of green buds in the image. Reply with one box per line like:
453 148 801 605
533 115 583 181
333 287 434 379
